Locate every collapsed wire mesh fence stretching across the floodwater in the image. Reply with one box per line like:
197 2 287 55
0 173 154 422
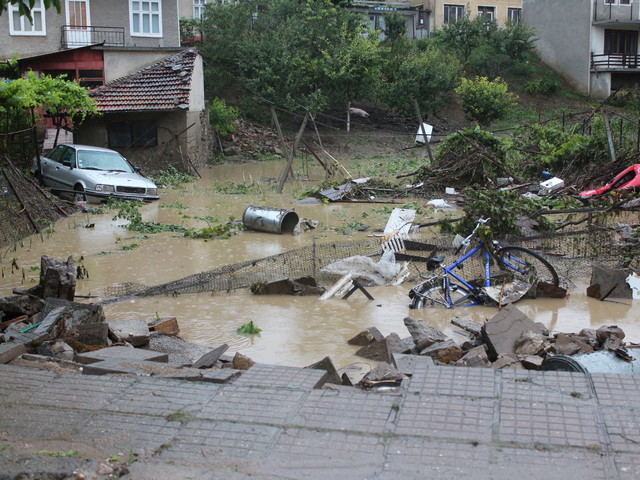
104 220 639 299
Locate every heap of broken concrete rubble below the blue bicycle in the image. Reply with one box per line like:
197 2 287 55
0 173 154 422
349 304 635 381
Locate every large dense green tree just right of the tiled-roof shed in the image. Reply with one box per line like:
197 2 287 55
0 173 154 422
202 0 363 111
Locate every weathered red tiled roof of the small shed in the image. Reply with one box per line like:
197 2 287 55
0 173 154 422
89 48 198 113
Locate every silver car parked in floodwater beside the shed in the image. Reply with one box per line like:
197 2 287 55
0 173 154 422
31 144 160 203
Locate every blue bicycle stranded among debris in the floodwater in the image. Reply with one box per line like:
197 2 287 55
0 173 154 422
409 218 560 308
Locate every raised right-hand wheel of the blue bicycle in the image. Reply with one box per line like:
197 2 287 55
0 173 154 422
496 245 560 287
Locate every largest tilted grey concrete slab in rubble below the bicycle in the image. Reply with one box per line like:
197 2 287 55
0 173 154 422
482 304 546 359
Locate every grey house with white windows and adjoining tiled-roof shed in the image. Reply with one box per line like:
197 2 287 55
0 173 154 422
0 0 208 170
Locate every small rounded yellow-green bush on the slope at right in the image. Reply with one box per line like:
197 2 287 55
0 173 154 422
455 77 518 126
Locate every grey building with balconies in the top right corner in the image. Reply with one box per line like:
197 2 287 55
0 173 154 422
523 0 640 99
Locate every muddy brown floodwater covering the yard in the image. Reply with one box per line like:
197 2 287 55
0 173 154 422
0 161 640 369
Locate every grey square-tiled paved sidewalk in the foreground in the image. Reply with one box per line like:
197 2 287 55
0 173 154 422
0 364 640 480
